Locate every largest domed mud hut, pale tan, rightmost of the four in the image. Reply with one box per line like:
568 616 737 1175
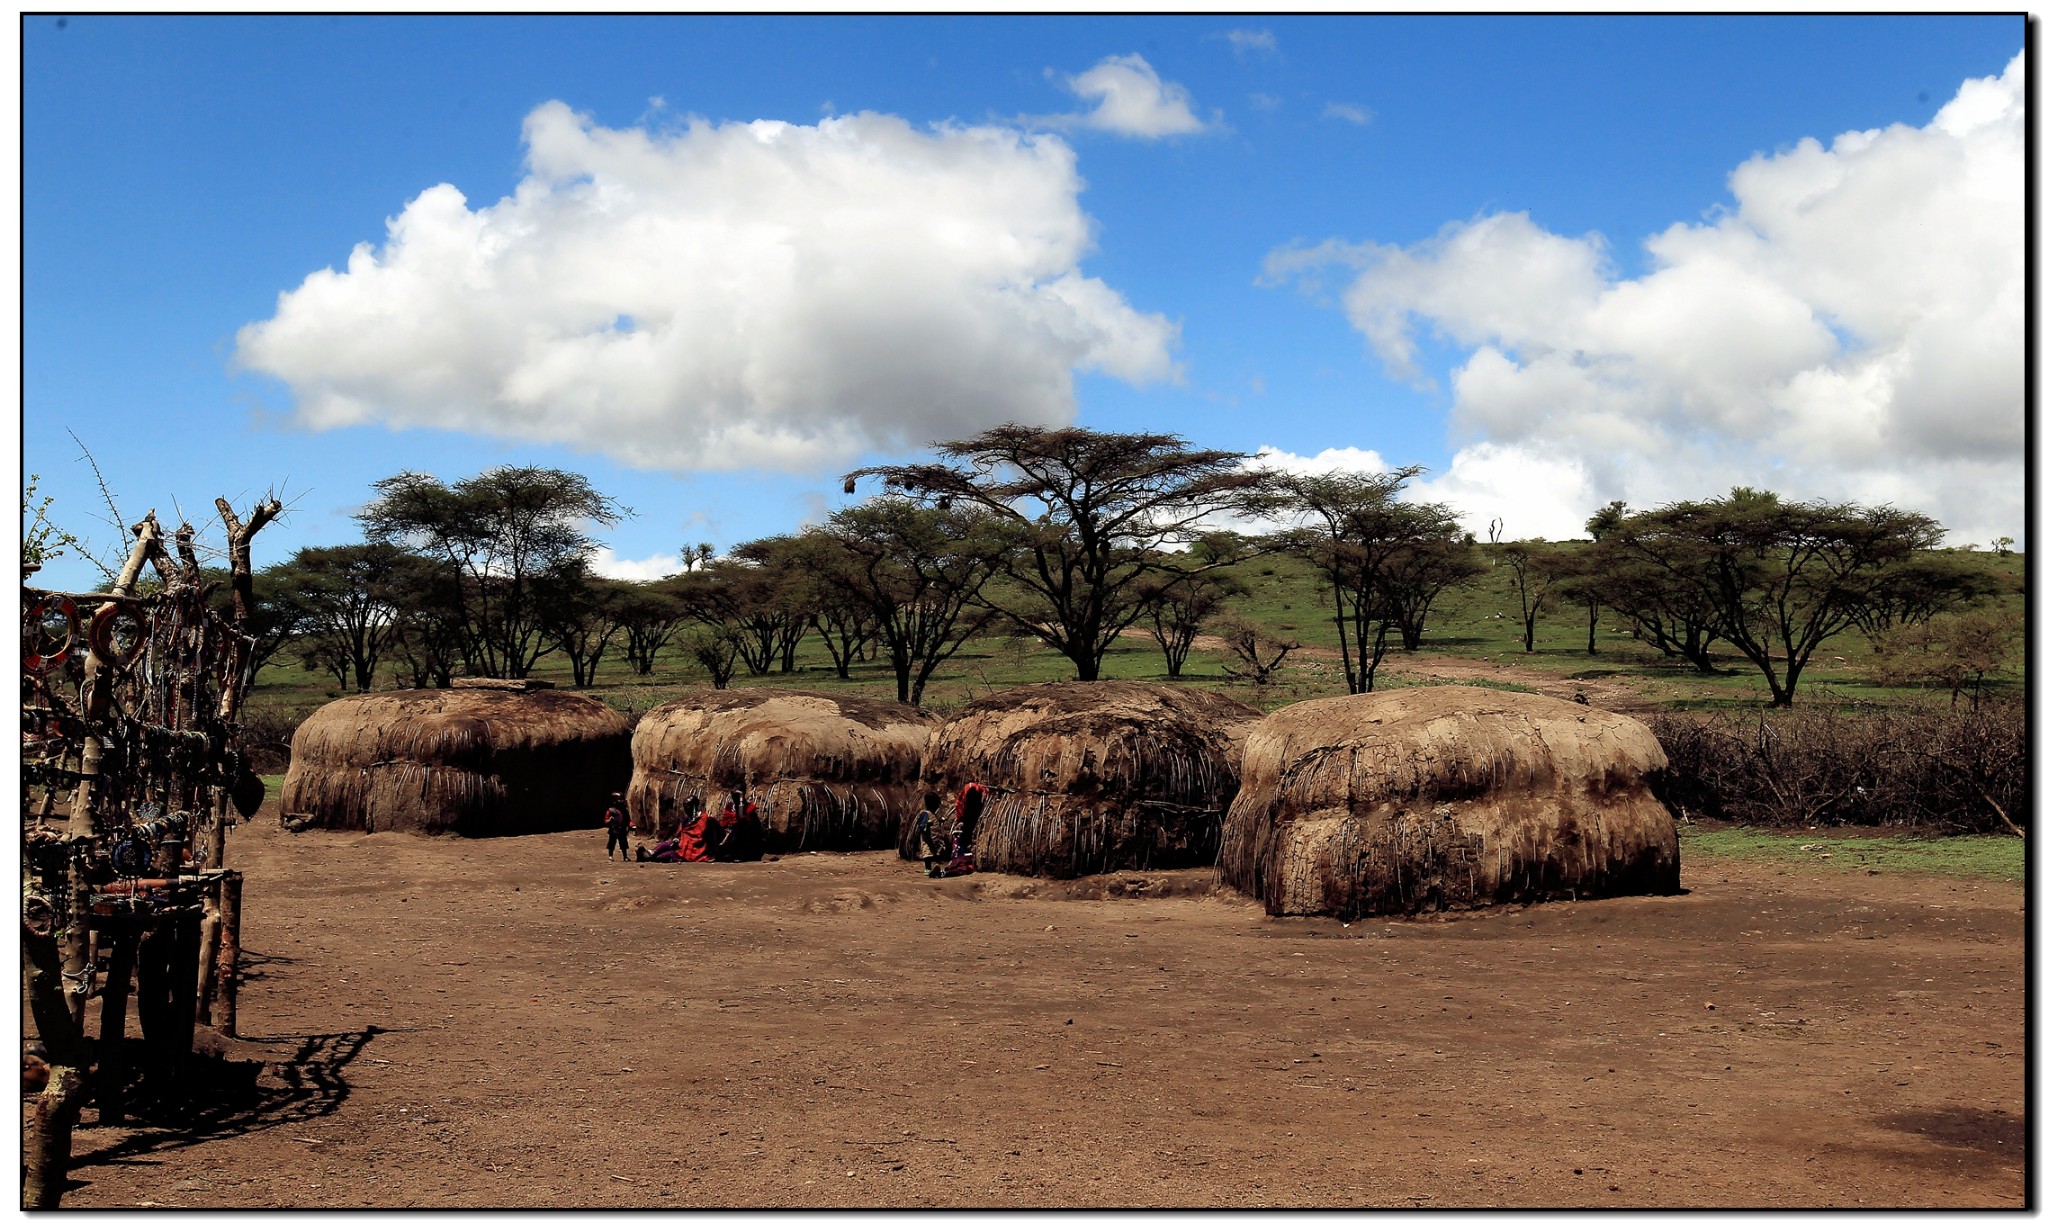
1219 686 1677 918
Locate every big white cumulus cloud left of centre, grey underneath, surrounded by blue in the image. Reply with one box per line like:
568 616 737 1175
236 102 1178 471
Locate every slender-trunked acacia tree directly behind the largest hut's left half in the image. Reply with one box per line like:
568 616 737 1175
1241 467 1458 692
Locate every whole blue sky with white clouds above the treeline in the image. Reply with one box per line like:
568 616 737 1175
23 16 2025 582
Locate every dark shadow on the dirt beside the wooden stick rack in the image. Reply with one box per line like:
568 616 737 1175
74 1024 387 1168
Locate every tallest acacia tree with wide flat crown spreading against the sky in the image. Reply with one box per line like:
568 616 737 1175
846 424 1264 680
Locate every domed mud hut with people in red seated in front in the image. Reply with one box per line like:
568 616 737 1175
627 688 938 852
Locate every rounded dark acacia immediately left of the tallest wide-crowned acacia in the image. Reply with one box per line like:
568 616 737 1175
805 496 1008 705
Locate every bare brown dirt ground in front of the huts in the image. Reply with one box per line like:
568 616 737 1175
51 811 2025 1209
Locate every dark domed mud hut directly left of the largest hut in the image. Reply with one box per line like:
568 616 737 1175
917 680 1260 879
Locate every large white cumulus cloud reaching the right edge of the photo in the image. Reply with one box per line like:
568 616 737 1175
1266 57 2025 541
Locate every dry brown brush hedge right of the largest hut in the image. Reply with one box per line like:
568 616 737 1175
1647 701 2028 832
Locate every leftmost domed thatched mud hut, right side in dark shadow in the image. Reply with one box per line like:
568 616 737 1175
281 688 629 836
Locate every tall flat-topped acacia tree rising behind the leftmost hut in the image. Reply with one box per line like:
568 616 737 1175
358 467 629 678
